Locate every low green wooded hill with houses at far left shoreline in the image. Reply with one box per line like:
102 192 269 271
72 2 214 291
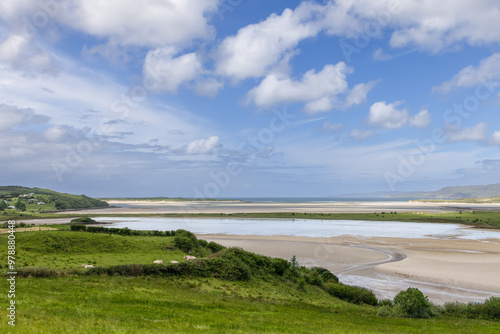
0 186 109 210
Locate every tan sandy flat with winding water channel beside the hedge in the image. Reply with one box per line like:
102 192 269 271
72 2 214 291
199 235 500 304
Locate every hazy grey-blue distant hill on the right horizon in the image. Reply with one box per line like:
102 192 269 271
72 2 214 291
389 183 500 199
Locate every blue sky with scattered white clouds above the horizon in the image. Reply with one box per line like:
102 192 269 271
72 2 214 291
0 0 500 197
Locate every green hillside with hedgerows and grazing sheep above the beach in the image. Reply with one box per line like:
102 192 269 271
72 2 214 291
0 226 500 333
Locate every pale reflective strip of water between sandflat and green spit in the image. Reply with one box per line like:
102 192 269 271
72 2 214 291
96 217 500 240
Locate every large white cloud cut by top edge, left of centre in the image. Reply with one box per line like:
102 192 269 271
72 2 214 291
58 0 219 48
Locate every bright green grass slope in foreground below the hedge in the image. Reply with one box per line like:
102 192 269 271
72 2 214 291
0 276 500 334
